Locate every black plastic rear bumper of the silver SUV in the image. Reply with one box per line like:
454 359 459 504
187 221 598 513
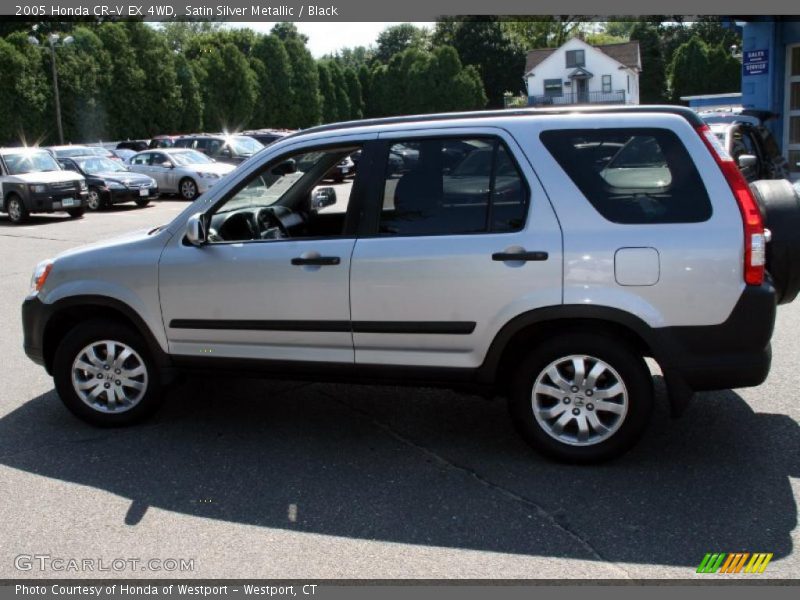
653 283 777 391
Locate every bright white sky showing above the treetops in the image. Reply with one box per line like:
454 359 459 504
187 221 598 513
227 21 434 58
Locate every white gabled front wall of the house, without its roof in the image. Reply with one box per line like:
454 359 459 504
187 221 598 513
527 38 639 104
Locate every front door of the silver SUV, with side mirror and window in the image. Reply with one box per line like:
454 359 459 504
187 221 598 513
159 135 375 365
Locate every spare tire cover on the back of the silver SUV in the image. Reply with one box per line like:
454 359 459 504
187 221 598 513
750 179 800 304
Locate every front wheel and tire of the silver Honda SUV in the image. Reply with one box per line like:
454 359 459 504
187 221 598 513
53 319 162 427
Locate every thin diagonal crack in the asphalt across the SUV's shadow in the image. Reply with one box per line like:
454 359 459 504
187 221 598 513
320 391 633 579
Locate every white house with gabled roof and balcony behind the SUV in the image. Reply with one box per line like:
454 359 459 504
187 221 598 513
525 38 642 106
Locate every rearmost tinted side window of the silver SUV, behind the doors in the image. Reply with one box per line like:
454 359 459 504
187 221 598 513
540 128 711 224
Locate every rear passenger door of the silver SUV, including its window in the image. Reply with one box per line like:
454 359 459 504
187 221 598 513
350 128 562 369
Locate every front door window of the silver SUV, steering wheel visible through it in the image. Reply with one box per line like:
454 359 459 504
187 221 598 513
208 145 361 244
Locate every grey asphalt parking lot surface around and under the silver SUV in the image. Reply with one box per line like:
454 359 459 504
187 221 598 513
0 200 800 579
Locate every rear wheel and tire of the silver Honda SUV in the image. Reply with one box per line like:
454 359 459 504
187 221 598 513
509 332 653 464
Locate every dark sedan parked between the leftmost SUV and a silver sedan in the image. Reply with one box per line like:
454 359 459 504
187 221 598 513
58 156 158 210
